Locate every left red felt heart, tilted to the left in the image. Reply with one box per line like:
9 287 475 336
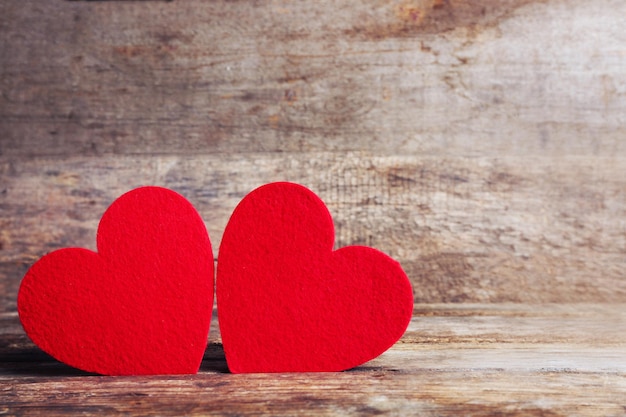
17 187 213 375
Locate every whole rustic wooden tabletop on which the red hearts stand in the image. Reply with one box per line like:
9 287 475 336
0 304 626 416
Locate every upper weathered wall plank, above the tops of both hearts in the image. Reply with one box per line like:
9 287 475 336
0 0 626 157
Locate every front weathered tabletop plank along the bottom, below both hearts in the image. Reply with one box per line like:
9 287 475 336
3 371 626 417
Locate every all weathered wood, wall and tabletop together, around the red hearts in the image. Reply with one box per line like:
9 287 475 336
0 0 626 415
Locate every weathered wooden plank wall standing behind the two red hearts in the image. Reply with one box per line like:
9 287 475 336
0 0 626 302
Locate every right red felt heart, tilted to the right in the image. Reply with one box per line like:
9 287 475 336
217 182 413 373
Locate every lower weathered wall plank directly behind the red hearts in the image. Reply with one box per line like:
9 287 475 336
0 152 626 302
